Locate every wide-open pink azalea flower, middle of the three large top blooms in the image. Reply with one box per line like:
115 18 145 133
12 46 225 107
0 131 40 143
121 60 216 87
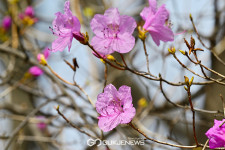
91 8 137 55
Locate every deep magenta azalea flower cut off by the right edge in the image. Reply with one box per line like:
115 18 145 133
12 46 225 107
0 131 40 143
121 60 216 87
205 119 225 149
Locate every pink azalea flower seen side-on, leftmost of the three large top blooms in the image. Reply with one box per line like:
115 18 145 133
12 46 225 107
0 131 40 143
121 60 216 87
51 1 84 52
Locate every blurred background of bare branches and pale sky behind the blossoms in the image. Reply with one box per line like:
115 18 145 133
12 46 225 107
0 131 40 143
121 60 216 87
0 0 225 150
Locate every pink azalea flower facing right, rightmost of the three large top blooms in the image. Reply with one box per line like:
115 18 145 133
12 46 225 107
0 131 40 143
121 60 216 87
140 0 174 46
